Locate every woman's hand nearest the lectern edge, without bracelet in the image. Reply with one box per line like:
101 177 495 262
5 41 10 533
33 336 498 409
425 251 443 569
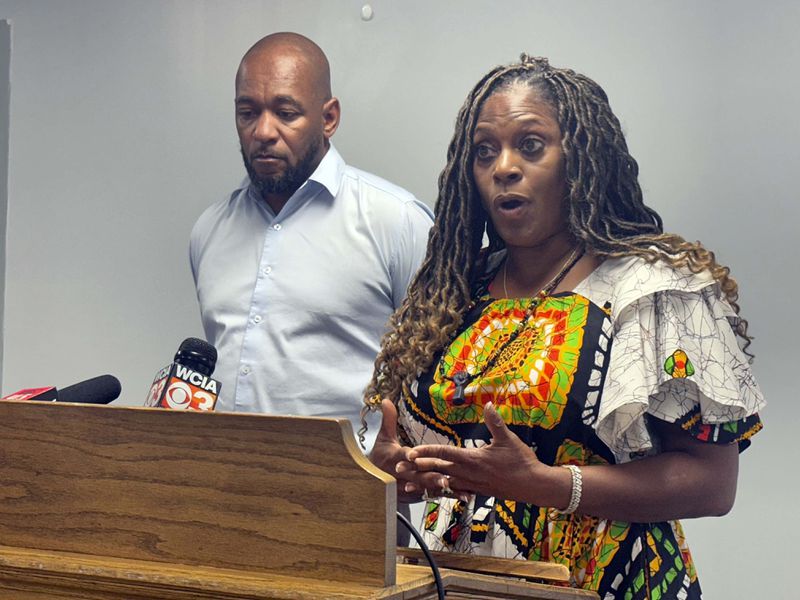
369 399 454 502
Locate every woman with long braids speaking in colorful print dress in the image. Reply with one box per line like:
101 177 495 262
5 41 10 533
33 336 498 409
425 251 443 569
365 55 764 599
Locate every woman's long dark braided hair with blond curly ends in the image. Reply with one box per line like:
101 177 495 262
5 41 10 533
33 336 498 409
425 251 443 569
362 54 751 432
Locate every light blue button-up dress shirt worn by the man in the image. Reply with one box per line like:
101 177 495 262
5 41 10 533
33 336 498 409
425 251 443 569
190 146 432 440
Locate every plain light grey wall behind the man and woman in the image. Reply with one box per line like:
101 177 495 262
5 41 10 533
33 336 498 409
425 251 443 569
0 0 800 599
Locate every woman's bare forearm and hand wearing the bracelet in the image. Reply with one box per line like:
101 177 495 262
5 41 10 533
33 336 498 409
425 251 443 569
407 404 739 523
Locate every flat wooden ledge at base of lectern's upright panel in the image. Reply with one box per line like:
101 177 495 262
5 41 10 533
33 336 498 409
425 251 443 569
0 546 599 600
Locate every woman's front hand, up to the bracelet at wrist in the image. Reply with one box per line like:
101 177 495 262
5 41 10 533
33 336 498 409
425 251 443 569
406 403 572 508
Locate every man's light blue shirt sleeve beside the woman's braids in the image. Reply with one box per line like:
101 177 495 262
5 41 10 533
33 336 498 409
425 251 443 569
391 200 433 310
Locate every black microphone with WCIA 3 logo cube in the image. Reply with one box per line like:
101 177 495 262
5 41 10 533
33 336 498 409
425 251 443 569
144 338 222 411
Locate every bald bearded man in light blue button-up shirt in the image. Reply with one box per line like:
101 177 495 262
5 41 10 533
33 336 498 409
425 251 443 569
190 33 432 446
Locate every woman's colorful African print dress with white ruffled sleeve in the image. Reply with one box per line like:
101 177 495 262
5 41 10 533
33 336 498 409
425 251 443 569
399 257 764 600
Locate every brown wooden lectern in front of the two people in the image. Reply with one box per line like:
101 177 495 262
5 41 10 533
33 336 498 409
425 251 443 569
0 401 597 600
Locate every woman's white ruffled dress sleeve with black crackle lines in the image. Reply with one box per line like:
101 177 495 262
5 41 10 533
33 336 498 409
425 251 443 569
596 261 765 461
